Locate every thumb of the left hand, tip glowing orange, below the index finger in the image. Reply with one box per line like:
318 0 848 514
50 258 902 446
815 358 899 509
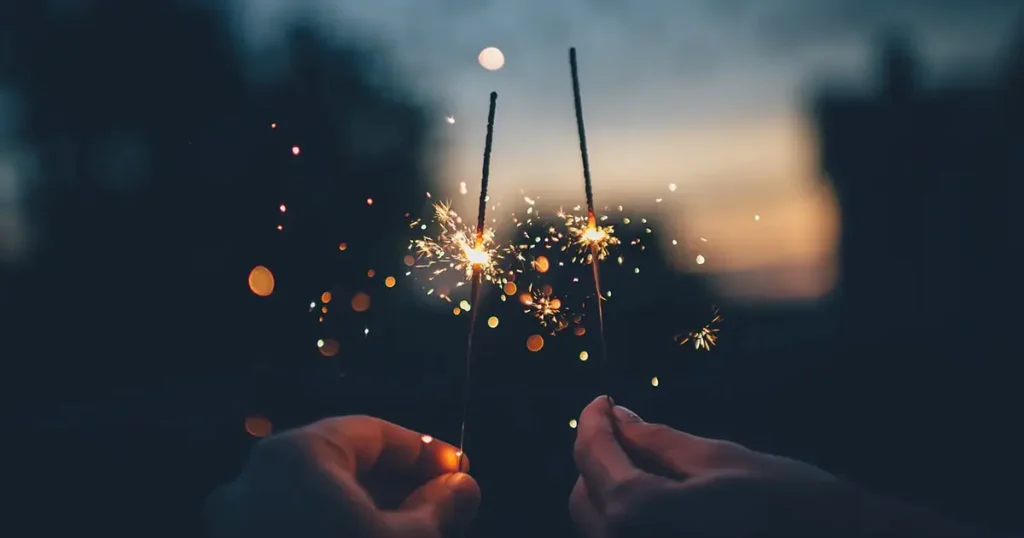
385 472 480 538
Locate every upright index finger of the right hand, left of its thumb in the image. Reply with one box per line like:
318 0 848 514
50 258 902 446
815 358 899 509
572 396 640 504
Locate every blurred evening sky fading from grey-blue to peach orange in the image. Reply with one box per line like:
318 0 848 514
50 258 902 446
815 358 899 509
4 0 1022 299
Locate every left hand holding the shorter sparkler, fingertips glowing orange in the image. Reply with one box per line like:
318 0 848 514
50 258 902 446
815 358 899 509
207 416 480 538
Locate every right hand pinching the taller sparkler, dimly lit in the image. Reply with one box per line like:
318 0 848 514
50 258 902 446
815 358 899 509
569 397 862 538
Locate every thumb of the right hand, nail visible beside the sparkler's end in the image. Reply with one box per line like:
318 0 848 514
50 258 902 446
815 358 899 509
612 406 745 479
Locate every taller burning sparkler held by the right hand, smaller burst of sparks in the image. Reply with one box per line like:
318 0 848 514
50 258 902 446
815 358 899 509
569 47 612 368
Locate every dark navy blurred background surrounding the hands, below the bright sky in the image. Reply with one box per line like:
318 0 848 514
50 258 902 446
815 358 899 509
0 0 1024 536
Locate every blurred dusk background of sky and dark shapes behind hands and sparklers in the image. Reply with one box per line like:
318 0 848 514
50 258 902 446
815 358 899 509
6 0 1024 536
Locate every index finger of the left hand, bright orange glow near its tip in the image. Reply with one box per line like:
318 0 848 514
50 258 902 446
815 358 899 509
301 416 469 480
